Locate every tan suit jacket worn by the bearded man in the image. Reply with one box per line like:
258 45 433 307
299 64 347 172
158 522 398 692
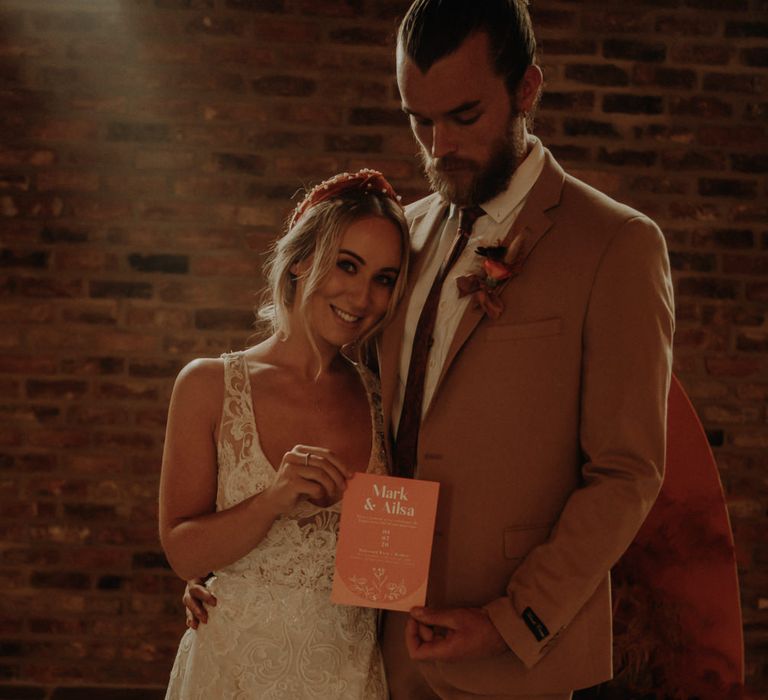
380 151 673 695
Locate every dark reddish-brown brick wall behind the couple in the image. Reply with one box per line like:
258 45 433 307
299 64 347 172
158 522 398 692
0 0 768 699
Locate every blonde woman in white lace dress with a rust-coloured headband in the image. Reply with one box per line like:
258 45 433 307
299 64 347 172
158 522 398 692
160 170 408 700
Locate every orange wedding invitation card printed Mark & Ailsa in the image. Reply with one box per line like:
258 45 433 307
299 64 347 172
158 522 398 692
331 472 439 611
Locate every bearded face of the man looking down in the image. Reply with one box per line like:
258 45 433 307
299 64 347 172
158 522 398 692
397 32 525 205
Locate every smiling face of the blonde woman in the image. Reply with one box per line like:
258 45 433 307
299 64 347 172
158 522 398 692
296 216 402 348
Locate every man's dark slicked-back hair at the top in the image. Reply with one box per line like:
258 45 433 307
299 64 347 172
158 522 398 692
397 0 536 95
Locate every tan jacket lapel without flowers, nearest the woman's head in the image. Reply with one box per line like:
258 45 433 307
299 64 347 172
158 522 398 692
379 195 448 431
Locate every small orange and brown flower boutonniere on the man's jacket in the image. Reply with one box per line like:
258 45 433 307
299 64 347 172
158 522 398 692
456 236 523 320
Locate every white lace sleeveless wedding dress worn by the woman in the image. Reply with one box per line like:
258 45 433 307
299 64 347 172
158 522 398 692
166 353 387 700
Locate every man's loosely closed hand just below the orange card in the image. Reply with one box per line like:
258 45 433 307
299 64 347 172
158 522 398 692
405 608 509 661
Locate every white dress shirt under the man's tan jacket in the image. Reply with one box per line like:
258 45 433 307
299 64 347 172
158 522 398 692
392 136 544 434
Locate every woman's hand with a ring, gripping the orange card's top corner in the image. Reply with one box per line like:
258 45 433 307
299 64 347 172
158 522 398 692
263 445 354 515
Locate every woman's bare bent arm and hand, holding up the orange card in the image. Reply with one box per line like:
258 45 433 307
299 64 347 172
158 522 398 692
160 360 348 579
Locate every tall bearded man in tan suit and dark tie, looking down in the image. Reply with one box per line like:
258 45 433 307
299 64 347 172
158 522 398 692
380 0 673 700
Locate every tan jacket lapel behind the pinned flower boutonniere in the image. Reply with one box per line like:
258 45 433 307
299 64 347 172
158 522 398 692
425 149 565 410
